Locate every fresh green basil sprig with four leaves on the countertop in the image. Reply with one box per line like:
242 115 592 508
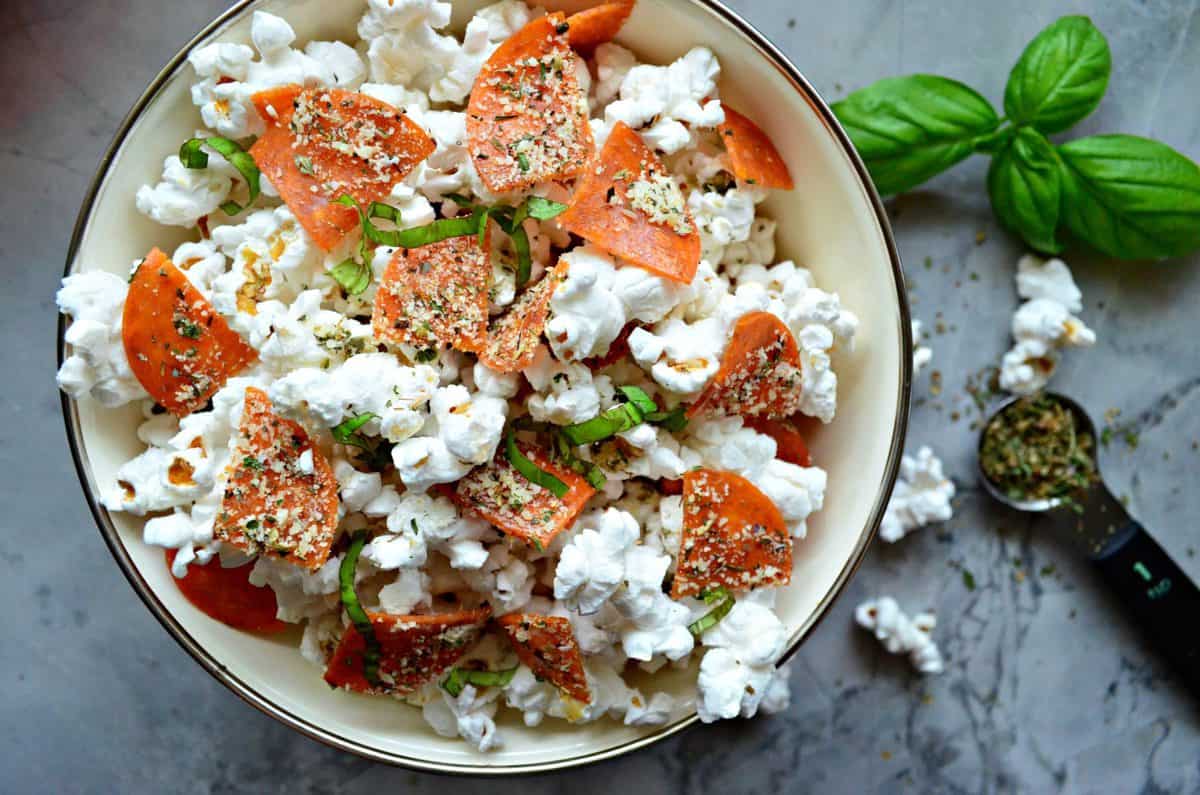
833 17 1200 259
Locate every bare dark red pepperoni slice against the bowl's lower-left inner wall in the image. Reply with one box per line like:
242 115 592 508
167 549 289 634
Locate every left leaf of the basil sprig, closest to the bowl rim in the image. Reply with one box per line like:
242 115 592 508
833 74 1000 196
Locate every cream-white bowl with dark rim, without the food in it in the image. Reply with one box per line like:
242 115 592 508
59 0 912 773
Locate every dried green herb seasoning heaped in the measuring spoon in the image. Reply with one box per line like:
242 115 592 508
979 394 1099 510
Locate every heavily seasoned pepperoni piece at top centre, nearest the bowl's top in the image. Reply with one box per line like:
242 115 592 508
467 13 592 193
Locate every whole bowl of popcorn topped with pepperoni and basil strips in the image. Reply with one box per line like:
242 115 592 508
51 0 912 773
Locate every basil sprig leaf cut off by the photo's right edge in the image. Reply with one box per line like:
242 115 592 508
1058 135 1200 259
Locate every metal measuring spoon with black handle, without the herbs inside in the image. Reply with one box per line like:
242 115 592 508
977 393 1200 694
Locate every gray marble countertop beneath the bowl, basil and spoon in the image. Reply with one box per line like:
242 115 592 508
0 0 1200 795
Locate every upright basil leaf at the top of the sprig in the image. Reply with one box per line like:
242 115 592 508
1004 17 1112 135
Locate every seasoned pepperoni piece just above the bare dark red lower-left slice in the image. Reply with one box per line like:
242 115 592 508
214 387 337 569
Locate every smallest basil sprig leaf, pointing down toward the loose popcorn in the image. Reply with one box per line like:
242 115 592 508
988 127 1062 253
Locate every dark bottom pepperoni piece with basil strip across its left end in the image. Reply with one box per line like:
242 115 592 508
325 606 492 694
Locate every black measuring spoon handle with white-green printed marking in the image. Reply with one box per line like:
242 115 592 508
1093 520 1200 697
